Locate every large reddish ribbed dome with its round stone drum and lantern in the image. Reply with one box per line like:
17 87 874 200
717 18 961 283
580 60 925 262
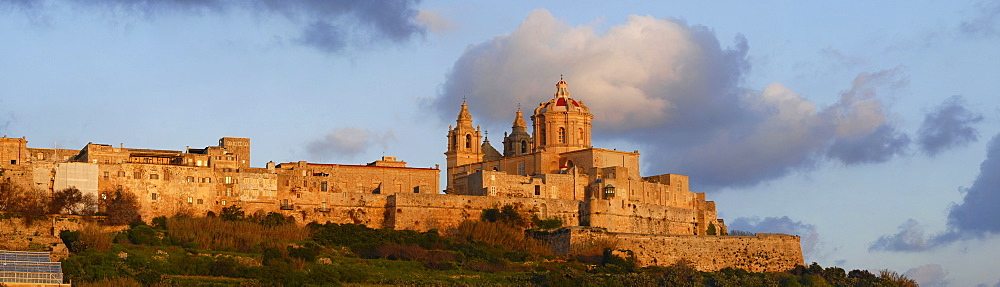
531 79 594 153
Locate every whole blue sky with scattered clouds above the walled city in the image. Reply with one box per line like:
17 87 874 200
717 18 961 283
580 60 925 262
0 0 1000 286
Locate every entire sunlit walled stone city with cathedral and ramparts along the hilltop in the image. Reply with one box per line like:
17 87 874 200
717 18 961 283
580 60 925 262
0 80 803 271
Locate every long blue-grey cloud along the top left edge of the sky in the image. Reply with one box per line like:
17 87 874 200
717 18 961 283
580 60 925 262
0 0 426 52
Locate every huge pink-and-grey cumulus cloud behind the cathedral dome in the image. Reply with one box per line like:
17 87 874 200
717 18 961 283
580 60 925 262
430 10 909 190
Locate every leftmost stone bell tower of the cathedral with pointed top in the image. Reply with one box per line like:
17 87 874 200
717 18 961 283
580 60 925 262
444 101 483 194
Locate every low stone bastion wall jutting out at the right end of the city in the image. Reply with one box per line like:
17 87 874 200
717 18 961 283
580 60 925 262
554 228 804 272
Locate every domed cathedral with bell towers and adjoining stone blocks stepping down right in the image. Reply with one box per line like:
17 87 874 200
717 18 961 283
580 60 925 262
445 80 725 235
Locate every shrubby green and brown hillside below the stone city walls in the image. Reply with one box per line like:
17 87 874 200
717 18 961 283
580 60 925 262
54 206 912 286
